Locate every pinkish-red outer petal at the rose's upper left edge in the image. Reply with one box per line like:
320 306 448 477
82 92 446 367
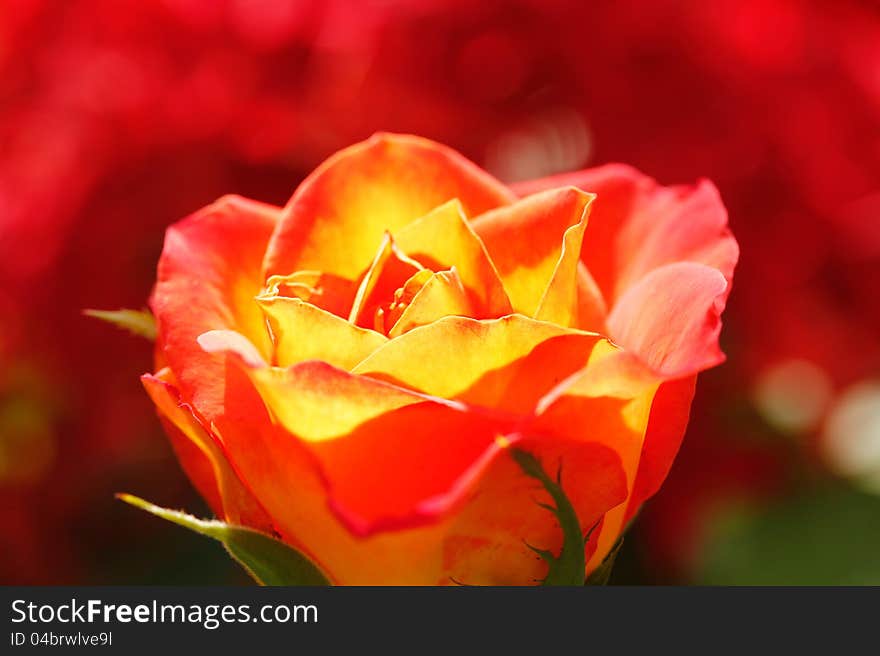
150 196 280 423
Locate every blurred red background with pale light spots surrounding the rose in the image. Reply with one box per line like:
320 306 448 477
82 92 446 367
0 0 880 583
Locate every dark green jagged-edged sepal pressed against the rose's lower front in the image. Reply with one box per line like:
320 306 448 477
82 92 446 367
511 449 596 585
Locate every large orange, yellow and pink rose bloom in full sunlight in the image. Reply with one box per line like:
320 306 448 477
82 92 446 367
143 135 737 584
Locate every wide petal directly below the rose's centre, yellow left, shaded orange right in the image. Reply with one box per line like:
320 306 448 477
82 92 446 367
353 314 600 413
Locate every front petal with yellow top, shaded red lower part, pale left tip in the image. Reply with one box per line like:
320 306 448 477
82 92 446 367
200 332 504 534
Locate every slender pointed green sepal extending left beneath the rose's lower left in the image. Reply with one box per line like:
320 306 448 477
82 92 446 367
116 494 331 585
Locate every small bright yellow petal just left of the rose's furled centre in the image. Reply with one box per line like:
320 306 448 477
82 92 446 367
256 296 388 369
